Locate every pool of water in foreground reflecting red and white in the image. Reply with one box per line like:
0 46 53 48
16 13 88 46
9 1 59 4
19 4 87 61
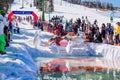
36 57 120 80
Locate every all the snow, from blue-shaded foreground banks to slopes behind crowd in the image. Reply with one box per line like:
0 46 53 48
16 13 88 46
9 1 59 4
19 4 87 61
0 0 120 80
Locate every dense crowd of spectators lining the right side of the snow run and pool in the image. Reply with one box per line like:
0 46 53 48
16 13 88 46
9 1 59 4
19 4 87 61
33 16 120 45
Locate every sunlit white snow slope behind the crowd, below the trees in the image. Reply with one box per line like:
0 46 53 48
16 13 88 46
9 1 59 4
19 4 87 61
51 0 120 24
